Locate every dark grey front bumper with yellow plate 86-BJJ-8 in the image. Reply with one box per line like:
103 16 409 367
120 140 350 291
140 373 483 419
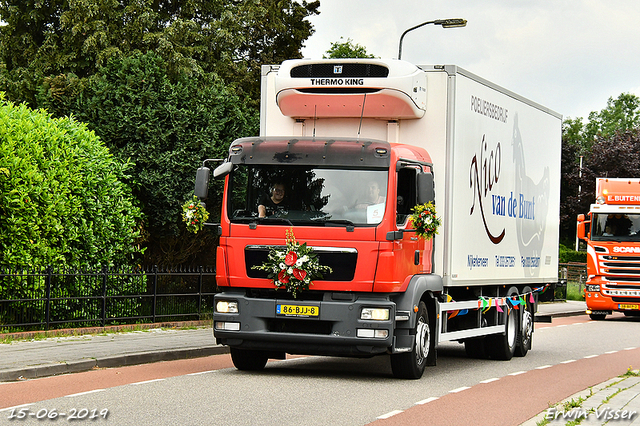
213 290 395 356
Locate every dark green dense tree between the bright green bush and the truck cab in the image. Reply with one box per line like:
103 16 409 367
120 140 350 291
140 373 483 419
58 53 258 264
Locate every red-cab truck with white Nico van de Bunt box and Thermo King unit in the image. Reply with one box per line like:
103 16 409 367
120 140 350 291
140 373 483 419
196 59 562 379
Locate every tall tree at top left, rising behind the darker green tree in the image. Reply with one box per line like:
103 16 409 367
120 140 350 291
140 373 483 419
0 0 320 106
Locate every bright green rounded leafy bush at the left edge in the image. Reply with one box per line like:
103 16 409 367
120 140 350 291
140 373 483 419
0 94 142 267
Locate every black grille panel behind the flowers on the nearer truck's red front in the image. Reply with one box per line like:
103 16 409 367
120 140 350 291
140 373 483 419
244 245 358 281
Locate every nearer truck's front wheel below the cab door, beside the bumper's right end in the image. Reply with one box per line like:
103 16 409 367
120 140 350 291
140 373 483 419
391 302 435 380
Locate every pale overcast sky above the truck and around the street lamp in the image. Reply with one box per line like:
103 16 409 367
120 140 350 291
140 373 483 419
302 0 640 121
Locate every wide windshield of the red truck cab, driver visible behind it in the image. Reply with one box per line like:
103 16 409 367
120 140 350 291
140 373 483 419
228 165 388 226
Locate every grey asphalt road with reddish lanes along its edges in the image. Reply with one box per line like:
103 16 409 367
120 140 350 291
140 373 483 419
0 315 640 426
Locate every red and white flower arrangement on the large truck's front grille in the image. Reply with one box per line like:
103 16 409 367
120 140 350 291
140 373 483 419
252 229 332 298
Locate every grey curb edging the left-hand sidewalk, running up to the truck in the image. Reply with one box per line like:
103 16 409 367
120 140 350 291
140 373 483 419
0 345 229 382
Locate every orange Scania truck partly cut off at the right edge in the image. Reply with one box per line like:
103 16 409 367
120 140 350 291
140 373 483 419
578 178 640 320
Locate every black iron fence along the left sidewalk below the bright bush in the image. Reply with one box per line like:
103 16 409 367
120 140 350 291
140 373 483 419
0 266 216 331
